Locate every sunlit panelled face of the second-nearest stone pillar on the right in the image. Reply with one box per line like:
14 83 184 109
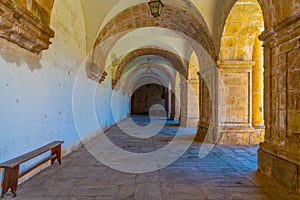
218 61 263 145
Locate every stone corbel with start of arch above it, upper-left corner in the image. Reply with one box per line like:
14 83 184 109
0 0 54 54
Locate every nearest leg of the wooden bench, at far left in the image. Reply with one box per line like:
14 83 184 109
1 165 20 198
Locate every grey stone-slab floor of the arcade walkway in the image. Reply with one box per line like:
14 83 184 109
5 118 300 200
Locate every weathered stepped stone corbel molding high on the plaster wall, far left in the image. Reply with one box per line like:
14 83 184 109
0 0 54 54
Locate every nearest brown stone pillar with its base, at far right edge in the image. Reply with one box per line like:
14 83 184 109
258 13 300 194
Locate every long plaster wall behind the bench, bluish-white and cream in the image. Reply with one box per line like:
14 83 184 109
0 0 129 191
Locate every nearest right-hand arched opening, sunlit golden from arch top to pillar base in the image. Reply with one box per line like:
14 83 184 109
218 0 264 144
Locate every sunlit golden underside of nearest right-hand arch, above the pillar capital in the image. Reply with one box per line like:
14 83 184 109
219 0 264 61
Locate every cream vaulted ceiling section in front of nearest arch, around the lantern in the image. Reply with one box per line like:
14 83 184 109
81 0 241 54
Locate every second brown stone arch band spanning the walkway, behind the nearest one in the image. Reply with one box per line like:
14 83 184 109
112 47 187 88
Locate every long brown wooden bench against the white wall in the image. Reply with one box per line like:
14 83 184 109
0 141 64 198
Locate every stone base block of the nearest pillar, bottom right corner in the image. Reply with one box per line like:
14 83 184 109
258 143 300 194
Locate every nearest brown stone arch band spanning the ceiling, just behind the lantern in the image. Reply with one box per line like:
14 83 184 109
94 3 215 58
